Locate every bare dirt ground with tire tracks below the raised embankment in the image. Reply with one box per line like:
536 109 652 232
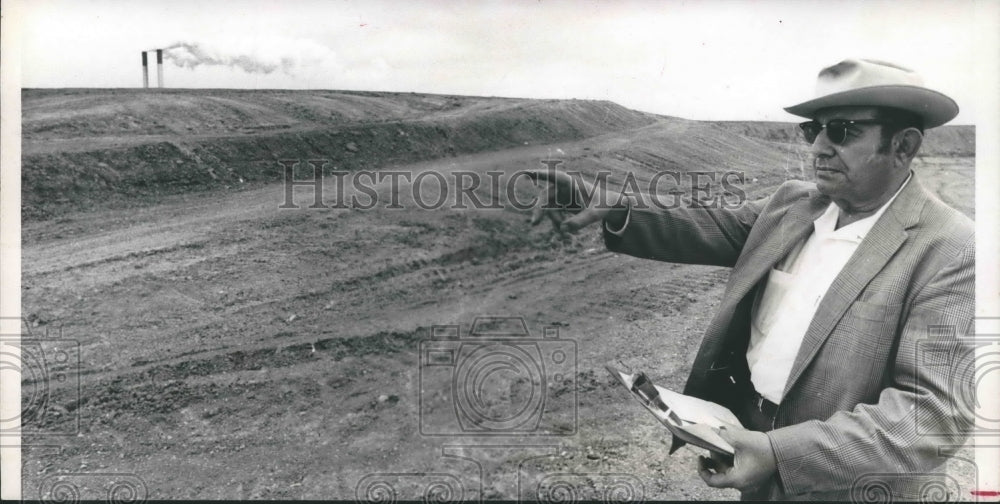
22 91 973 500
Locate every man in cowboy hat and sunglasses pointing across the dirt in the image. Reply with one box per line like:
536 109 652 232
533 60 975 500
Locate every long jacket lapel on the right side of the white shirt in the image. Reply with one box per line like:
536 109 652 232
784 174 927 395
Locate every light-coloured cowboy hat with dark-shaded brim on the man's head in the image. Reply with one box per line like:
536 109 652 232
785 59 958 128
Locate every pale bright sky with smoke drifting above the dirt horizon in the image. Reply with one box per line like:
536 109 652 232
11 0 1000 124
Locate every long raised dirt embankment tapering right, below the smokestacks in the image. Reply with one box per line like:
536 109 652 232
22 90 654 220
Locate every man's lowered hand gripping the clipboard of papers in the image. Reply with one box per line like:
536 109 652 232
698 427 778 490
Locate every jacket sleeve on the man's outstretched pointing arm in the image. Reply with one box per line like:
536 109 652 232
603 198 771 267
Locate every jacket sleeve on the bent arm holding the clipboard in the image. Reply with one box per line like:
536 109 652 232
768 237 975 494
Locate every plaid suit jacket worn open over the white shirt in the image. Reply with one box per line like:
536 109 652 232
605 174 975 500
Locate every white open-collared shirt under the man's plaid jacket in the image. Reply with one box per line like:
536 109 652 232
747 175 912 403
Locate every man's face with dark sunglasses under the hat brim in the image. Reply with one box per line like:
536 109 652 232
812 107 899 209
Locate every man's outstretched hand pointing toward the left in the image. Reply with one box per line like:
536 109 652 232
527 170 611 233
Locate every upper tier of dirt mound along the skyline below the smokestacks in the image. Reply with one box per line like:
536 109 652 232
22 89 502 140
